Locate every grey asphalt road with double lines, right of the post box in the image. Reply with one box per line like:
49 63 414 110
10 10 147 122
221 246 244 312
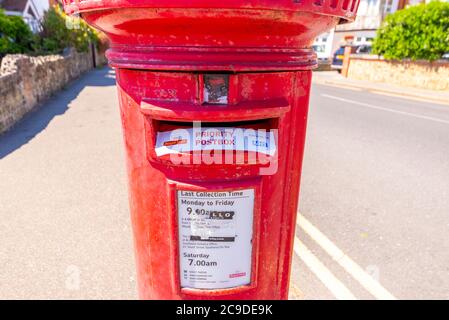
296 85 449 299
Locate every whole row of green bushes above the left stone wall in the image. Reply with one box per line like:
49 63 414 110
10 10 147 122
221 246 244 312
0 6 99 57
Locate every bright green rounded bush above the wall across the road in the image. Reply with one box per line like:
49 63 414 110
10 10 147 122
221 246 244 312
373 2 449 61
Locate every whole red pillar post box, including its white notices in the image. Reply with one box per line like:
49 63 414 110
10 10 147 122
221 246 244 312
65 0 359 299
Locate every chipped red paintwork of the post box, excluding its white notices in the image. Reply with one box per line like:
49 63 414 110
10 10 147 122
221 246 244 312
64 0 358 299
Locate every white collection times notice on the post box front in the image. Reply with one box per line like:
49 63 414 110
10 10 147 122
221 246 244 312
177 189 254 289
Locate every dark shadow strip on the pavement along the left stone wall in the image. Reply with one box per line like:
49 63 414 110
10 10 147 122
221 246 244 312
0 68 115 159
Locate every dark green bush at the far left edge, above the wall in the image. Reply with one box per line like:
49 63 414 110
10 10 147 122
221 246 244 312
0 10 35 56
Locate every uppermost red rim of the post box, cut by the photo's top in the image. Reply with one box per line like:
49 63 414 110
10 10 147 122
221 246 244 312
63 0 360 23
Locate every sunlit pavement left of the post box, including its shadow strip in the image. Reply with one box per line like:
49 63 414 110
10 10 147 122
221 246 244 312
0 69 137 299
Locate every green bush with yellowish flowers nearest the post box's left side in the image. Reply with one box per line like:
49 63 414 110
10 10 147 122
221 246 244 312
40 6 98 53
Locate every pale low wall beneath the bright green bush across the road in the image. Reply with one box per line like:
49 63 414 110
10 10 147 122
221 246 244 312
348 55 449 90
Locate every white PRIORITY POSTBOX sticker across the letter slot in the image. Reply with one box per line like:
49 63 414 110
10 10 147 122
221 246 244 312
155 127 276 157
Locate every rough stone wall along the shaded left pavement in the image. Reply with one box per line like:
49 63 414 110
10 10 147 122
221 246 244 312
0 51 93 134
